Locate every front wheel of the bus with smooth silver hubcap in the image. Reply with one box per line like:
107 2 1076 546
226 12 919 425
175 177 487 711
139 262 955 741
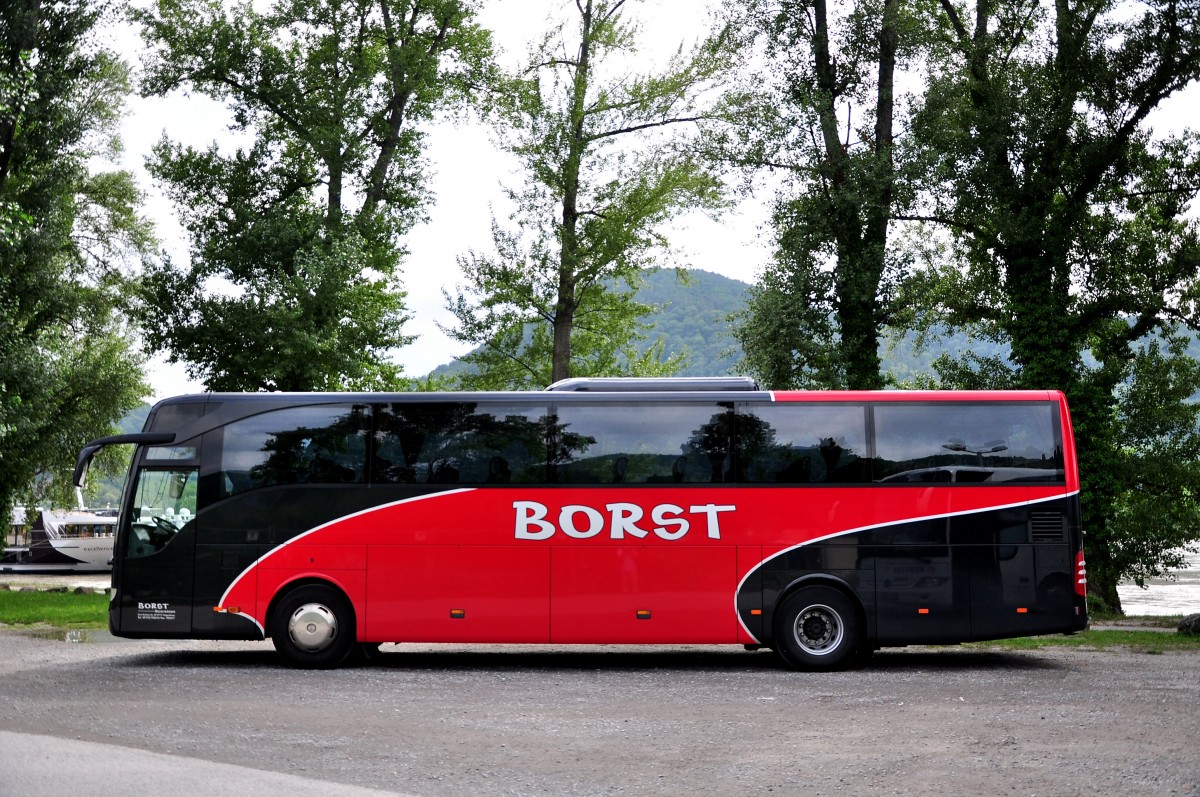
271 585 355 670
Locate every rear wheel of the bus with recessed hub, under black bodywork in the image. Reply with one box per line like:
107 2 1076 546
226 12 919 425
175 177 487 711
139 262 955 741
774 587 863 671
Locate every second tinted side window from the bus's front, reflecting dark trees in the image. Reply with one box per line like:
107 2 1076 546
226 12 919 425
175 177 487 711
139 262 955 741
372 402 547 484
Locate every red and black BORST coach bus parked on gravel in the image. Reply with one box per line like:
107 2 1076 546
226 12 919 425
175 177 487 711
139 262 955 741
76 378 1087 670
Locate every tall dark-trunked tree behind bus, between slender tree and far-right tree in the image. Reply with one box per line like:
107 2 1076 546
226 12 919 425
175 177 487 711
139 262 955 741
712 0 918 389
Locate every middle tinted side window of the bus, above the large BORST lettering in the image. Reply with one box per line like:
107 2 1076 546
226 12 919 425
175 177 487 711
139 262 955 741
556 402 733 484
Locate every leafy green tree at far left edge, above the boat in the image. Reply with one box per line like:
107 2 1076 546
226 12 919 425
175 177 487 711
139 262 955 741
0 0 154 522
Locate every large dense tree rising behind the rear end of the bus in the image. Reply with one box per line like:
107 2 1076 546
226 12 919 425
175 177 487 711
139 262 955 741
908 0 1200 609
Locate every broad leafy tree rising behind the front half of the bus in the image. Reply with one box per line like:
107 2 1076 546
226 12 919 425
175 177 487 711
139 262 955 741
134 0 491 390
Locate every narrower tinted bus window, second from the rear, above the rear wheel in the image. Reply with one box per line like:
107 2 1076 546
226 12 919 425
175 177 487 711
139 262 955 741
738 403 869 484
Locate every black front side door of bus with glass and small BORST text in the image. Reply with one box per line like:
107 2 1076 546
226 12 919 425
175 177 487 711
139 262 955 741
109 468 198 636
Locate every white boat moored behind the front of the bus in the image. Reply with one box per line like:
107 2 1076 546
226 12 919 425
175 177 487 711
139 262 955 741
0 509 116 573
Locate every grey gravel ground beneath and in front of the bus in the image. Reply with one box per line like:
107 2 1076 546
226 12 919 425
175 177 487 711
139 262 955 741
0 630 1200 797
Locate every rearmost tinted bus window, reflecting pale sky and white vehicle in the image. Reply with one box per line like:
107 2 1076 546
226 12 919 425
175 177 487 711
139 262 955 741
875 403 1064 484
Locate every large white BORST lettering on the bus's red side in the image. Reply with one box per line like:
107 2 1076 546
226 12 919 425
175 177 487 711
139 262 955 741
512 501 737 540
